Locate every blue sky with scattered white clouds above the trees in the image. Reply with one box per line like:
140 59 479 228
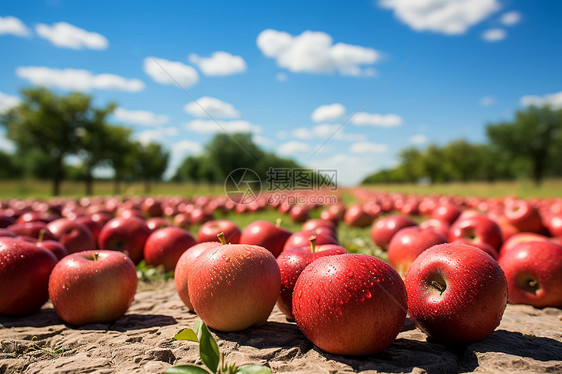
0 0 562 185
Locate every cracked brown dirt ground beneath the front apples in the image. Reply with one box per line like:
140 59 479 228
0 282 562 374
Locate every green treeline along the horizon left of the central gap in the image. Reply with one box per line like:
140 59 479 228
0 88 329 195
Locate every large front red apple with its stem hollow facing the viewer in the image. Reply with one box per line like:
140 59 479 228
405 243 507 343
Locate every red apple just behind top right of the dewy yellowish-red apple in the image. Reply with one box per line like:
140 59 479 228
240 220 290 257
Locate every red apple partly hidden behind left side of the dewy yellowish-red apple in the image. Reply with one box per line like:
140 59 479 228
143 226 197 271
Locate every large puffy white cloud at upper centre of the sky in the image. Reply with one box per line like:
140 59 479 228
257 29 381 75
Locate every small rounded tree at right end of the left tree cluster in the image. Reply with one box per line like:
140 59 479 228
132 142 170 193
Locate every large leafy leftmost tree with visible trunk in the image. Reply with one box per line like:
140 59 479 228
0 88 112 195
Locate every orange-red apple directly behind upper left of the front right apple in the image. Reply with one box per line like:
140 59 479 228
387 226 447 278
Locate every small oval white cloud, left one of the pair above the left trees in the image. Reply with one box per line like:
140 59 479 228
144 57 199 87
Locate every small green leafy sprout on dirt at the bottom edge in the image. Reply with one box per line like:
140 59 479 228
164 321 271 374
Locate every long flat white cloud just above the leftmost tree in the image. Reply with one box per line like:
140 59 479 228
16 66 144 92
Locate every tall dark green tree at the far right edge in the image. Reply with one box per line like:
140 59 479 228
486 106 562 185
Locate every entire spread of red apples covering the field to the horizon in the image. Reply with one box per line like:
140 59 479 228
0 189 562 355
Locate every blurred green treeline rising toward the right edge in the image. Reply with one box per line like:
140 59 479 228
362 106 562 184
